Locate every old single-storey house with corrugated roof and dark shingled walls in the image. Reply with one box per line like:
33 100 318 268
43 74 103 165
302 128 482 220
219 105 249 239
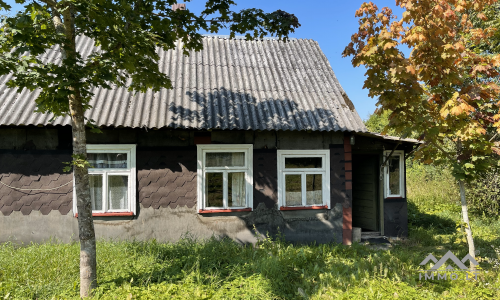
0 36 416 244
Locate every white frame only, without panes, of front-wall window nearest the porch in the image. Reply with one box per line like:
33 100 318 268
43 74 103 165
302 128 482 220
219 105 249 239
278 150 330 208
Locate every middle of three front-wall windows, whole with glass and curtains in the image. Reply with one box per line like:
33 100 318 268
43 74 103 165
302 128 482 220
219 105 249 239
198 144 253 212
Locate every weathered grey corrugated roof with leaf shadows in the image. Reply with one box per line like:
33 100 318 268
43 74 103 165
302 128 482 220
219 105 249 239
0 36 367 132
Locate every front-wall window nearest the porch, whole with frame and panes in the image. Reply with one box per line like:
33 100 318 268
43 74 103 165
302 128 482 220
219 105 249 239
278 150 330 208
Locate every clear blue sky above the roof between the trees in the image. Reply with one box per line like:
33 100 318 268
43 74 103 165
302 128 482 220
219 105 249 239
6 0 402 119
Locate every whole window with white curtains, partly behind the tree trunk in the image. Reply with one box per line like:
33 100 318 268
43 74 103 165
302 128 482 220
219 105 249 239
73 144 136 215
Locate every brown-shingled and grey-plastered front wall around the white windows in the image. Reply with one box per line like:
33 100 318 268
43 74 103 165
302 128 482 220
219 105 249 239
0 147 342 243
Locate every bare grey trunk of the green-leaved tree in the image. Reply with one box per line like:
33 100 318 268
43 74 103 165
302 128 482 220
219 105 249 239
53 5 97 298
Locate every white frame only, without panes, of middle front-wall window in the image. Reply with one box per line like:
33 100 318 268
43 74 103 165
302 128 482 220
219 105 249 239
197 144 253 212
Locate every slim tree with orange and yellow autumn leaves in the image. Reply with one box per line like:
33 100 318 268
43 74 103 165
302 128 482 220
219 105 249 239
343 0 500 268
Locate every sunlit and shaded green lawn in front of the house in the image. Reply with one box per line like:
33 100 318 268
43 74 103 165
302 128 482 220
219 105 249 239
0 169 500 299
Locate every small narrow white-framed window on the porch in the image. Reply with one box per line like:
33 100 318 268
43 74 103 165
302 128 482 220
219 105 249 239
384 150 405 197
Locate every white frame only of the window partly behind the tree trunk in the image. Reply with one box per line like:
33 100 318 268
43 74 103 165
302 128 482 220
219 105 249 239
73 144 137 216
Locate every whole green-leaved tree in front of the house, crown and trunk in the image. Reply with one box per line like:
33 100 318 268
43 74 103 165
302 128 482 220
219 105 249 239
0 0 300 297
